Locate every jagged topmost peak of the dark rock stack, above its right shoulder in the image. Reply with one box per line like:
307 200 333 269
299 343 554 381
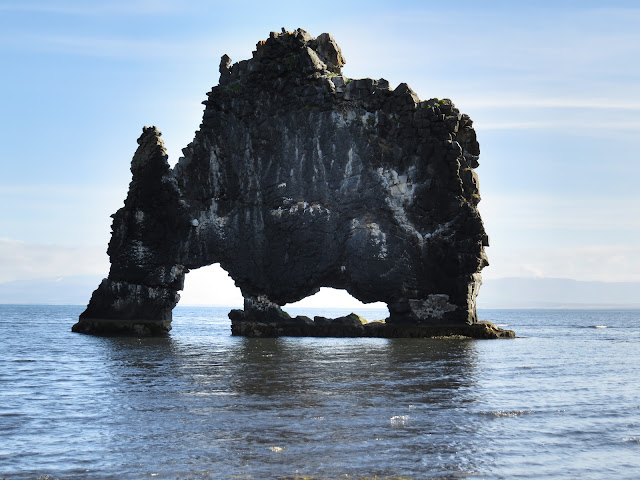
220 28 345 85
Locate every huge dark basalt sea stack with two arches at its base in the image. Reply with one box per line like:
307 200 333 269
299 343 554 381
74 30 512 338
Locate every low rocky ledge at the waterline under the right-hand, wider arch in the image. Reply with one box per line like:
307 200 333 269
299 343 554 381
229 310 516 339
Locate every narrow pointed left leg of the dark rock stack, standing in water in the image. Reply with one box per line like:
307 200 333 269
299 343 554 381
73 127 191 335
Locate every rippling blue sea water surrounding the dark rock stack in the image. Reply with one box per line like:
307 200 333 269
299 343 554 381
0 305 640 480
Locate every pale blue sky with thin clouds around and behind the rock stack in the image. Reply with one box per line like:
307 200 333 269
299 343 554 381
0 0 640 304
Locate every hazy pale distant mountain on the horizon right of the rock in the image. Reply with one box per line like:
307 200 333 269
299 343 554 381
478 278 640 308
